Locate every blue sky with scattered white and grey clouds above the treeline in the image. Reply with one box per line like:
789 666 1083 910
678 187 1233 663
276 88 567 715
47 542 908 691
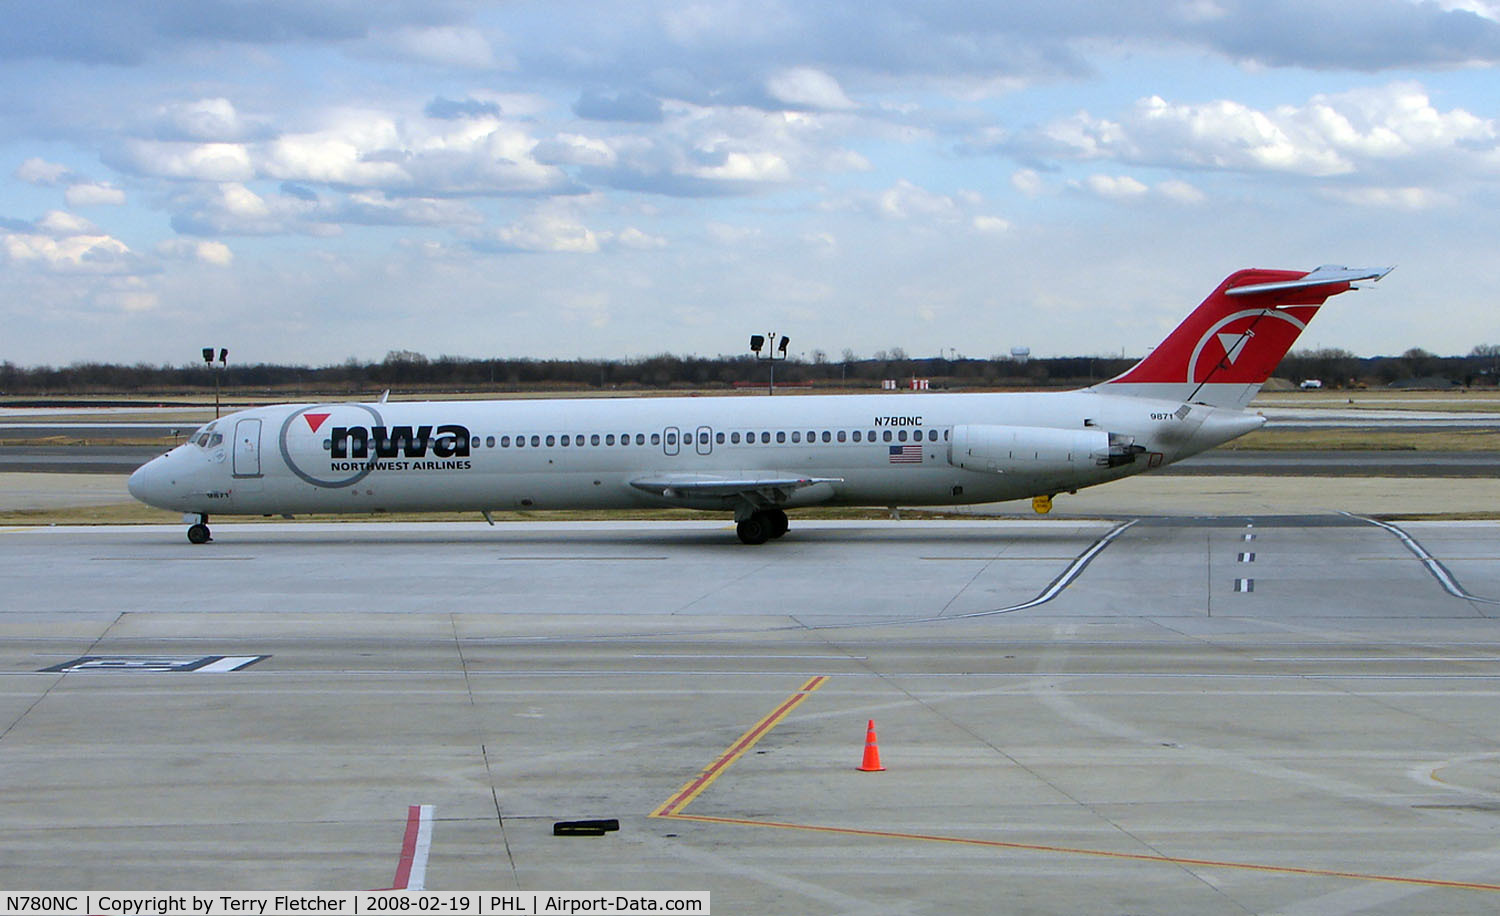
0 0 1500 366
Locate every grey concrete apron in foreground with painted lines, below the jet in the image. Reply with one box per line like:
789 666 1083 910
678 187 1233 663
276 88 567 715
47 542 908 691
0 514 1500 915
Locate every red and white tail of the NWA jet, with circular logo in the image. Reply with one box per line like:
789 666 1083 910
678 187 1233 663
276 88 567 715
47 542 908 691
1104 267 1391 408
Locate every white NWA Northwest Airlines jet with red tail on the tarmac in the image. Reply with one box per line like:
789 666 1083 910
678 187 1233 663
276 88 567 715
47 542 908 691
129 265 1392 544
